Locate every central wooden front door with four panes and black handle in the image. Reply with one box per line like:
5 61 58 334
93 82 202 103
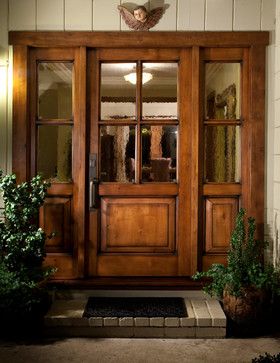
88 49 195 276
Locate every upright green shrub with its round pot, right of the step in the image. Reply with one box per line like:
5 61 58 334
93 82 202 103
193 209 280 334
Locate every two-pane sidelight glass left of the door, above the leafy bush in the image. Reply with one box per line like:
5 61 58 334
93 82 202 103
35 61 74 183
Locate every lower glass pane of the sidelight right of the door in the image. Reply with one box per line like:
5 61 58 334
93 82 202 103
204 126 240 183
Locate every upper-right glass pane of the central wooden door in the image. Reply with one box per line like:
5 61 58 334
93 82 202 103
142 63 178 119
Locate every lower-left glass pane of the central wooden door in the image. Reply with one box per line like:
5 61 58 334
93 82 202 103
100 126 135 183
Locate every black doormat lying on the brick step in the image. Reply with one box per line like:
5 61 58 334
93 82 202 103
83 297 187 318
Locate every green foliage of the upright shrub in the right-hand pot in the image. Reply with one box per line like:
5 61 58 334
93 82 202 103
193 209 280 298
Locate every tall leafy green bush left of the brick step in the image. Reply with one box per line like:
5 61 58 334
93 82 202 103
0 171 54 336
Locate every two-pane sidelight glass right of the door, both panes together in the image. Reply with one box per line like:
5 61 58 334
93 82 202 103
204 61 241 183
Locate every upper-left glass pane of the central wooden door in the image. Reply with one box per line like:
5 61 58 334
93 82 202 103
100 63 136 120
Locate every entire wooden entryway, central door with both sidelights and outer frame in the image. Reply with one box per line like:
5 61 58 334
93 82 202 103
10 32 269 287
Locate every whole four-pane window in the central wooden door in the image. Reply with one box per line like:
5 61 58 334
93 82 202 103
99 61 178 183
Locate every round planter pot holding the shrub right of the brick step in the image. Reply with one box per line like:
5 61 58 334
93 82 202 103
223 287 271 335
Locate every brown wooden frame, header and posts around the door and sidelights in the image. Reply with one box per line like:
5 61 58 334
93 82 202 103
9 31 269 288
